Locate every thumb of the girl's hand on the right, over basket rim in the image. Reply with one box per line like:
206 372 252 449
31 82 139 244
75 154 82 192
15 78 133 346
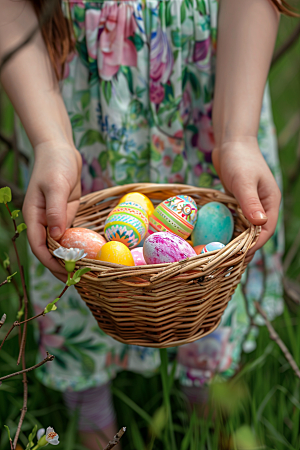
232 184 268 225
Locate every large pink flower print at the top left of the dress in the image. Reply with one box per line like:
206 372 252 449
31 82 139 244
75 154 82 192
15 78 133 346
98 3 137 81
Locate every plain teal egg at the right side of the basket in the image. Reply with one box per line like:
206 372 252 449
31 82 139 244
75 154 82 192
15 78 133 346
192 202 234 247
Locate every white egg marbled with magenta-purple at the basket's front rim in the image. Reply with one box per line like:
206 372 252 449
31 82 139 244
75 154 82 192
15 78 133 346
143 231 196 264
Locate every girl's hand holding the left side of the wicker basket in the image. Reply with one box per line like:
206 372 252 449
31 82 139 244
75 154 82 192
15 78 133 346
23 142 81 281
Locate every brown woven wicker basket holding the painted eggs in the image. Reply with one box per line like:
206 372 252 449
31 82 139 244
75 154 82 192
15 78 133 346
48 183 260 348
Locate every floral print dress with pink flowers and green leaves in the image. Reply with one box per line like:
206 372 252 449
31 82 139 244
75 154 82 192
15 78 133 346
20 0 283 391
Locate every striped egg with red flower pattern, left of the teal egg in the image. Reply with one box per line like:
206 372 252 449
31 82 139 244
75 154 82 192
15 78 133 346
148 195 197 239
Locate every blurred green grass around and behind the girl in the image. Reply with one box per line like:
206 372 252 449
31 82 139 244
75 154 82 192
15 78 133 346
0 9 300 450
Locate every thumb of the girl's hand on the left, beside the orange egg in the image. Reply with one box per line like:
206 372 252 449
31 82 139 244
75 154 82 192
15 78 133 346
45 186 68 240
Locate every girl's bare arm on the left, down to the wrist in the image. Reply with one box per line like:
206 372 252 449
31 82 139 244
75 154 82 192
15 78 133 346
0 0 73 148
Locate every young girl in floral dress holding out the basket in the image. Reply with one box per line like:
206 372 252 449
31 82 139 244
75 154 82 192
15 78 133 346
0 0 288 449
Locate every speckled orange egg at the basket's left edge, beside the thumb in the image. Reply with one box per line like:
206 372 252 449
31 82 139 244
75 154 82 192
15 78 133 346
59 228 106 259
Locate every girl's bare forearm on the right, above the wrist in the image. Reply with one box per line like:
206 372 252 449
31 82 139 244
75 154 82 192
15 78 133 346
213 0 279 147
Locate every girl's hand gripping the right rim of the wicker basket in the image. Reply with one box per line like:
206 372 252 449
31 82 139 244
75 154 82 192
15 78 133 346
212 137 281 262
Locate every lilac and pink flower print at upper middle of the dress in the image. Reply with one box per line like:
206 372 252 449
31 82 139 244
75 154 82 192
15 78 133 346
150 27 174 104
